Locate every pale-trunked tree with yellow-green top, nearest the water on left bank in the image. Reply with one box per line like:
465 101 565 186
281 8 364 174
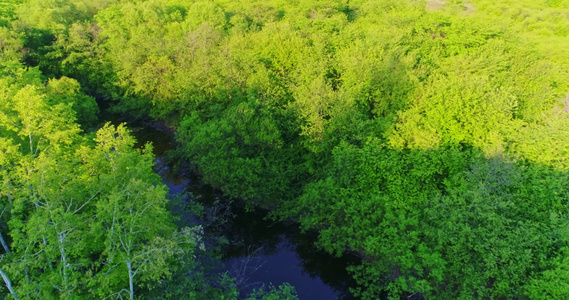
81 124 203 299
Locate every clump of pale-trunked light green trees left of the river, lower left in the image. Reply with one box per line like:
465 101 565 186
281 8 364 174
2 119 203 299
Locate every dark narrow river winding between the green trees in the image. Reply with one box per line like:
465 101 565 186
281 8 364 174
111 120 358 300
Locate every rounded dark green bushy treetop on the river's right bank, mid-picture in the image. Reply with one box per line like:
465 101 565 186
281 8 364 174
178 98 302 204
